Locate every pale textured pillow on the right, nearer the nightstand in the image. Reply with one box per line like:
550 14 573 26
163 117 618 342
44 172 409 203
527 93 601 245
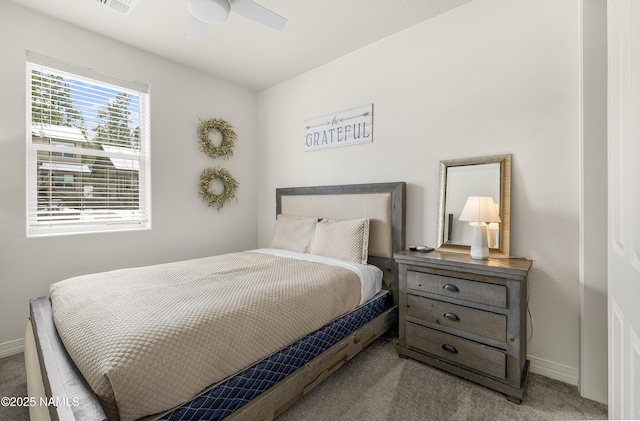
309 218 369 265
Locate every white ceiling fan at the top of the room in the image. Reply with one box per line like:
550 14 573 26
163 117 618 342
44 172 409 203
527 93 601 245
187 0 287 39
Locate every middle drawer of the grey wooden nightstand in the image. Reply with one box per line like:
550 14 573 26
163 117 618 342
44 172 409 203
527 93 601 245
407 294 507 342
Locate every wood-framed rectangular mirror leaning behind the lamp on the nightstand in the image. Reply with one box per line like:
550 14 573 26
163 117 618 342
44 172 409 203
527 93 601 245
436 154 511 257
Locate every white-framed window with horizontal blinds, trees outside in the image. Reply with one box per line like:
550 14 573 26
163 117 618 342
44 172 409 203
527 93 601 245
27 52 151 236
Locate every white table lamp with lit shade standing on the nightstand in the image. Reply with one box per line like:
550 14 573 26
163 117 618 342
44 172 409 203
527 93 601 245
458 196 502 259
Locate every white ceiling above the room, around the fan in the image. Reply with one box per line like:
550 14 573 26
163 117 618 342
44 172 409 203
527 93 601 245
11 0 471 91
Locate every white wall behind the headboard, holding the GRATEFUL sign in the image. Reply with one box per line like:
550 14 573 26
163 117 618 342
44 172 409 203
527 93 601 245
258 0 588 384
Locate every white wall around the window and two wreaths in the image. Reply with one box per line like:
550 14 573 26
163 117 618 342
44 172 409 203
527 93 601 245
0 1 257 348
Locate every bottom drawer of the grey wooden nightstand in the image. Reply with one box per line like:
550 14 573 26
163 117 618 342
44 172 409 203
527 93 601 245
406 323 507 379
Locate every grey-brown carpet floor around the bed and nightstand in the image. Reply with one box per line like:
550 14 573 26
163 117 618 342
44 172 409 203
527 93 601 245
0 337 607 421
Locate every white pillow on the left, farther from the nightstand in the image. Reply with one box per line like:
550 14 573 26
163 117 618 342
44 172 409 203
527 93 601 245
269 214 318 253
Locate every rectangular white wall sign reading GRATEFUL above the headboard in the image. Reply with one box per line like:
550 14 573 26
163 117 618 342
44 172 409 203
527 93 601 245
304 104 373 151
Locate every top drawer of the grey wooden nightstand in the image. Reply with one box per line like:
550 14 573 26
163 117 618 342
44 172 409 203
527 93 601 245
407 270 507 308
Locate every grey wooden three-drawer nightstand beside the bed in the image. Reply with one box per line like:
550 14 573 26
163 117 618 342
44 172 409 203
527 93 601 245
394 251 532 403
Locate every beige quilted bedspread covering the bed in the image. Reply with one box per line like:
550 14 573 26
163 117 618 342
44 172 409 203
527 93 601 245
50 252 360 421
